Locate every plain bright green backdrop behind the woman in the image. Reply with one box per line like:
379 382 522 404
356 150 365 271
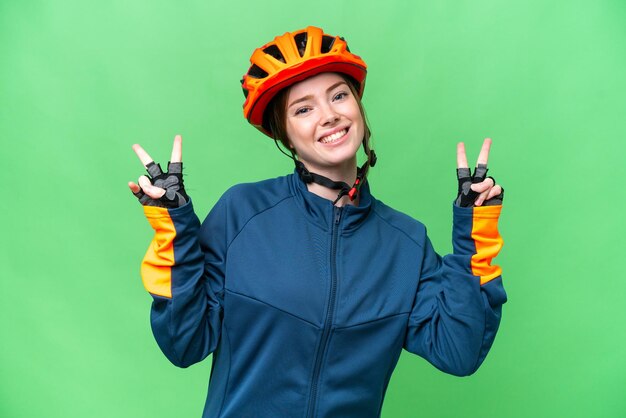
0 0 626 418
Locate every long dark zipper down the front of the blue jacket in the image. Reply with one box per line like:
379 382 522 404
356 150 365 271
307 206 342 418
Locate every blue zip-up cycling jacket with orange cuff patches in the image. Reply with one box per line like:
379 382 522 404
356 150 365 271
142 174 506 418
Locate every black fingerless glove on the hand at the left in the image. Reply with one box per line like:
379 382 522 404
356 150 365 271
133 161 190 208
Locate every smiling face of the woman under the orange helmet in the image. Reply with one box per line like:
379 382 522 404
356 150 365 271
285 73 365 174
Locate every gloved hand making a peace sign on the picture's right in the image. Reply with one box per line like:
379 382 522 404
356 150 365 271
454 138 504 207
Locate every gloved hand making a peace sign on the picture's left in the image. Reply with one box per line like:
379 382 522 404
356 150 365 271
128 135 190 208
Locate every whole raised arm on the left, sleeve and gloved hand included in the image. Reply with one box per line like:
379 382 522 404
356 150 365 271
129 135 226 367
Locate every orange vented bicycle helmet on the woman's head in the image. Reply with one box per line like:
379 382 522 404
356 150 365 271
241 26 367 137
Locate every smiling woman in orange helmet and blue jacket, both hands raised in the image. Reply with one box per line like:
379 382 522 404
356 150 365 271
129 27 506 418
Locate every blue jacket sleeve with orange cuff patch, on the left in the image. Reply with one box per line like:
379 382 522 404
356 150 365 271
141 198 226 367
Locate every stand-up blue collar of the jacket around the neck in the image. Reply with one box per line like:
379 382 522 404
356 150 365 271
289 172 375 231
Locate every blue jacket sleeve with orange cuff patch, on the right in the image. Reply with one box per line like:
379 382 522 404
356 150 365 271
404 206 506 376
